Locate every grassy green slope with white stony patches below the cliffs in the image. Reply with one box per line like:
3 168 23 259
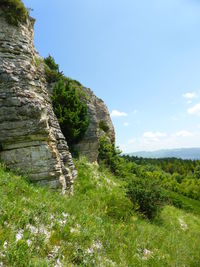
0 159 200 267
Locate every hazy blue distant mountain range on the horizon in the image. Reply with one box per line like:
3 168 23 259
129 148 200 160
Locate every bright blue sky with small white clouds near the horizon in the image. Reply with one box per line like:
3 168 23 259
24 0 200 153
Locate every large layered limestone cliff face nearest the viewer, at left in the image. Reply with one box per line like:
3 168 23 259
0 13 76 192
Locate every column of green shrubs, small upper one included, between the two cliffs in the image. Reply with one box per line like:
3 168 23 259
44 55 89 147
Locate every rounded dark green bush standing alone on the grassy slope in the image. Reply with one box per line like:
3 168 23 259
127 177 166 220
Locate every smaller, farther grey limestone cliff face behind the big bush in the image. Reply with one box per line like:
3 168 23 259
75 88 115 162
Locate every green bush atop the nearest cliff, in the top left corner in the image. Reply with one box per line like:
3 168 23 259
0 0 28 26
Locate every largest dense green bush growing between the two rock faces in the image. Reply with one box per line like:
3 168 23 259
52 79 89 146
